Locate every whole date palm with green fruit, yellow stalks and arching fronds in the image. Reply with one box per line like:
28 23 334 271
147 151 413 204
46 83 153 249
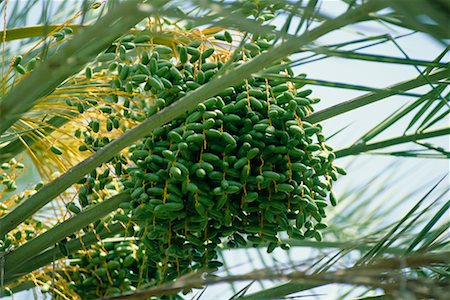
0 0 450 299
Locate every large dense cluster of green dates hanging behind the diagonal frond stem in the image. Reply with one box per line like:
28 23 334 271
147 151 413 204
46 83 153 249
118 39 340 280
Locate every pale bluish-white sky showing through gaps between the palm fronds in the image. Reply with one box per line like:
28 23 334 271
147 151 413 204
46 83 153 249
0 0 450 300
